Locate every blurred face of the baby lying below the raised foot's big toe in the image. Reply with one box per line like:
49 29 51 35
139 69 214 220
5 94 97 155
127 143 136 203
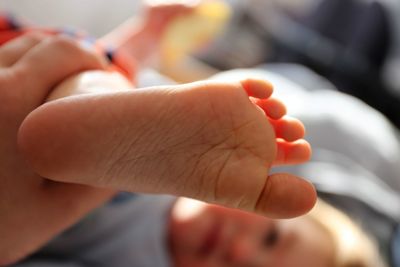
170 199 334 267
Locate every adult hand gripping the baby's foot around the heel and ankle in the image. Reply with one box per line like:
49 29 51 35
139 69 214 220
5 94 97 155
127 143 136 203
0 31 114 266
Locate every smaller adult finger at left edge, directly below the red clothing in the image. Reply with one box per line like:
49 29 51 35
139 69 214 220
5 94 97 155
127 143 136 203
0 32 49 68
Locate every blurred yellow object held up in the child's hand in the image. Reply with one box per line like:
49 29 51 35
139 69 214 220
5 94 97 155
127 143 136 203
161 0 231 64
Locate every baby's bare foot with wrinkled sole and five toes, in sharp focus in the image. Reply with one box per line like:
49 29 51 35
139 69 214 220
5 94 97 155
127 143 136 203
19 79 316 218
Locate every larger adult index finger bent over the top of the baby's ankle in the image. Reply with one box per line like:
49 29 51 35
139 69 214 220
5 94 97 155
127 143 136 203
11 36 107 112
